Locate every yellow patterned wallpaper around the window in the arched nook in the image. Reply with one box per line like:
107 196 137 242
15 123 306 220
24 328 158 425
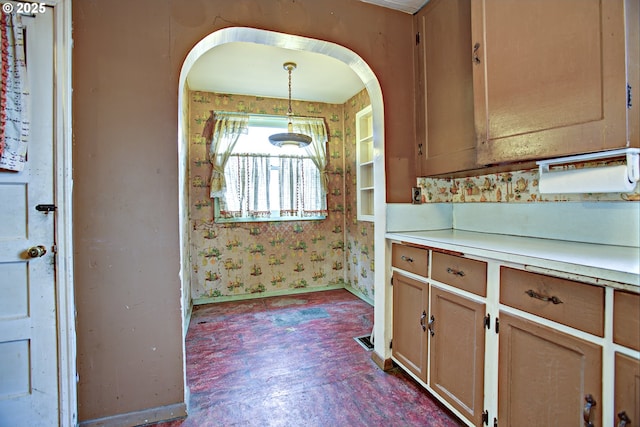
189 91 373 302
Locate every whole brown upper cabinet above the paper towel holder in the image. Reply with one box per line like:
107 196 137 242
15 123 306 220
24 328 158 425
415 0 640 176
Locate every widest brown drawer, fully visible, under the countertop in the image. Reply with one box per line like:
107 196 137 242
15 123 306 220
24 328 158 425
500 267 604 337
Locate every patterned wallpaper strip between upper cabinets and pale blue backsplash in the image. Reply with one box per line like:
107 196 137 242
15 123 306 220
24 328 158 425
417 161 640 203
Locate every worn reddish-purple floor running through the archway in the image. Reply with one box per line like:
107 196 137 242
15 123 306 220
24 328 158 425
148 290 460 427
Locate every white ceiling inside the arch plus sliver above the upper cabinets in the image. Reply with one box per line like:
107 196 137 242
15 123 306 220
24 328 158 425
187 0 428 104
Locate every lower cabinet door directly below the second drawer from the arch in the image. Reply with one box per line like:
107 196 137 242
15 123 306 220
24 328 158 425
429 286 485 425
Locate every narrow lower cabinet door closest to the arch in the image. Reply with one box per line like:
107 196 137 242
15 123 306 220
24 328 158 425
392 274 429 381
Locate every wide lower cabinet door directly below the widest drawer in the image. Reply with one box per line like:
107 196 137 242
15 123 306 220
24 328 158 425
498 312 602 427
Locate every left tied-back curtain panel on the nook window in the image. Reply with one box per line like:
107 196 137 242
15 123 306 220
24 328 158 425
202 111 249 198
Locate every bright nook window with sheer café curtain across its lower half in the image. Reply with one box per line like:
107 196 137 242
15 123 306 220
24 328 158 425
212 113 327 222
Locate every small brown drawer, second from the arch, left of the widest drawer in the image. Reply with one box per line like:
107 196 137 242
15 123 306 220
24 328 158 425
431 252 487 297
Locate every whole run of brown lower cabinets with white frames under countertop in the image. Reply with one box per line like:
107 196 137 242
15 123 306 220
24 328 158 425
391 240 640 427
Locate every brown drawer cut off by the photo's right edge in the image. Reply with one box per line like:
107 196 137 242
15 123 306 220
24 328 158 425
613 291 640 351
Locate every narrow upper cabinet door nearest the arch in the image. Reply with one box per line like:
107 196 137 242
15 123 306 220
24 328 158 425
416 0 476 176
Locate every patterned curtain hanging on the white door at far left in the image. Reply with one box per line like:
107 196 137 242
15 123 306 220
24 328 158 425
0 12 31 171
